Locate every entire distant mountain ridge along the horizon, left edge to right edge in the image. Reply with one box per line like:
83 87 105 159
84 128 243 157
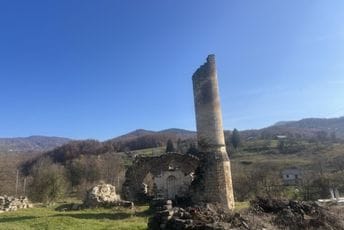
0 116 344 155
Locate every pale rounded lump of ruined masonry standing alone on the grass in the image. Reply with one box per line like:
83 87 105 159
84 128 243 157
82 183 134 209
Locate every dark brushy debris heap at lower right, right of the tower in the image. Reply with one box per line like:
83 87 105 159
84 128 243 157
250 198 344 230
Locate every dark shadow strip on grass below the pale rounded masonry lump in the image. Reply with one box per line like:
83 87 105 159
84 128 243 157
53 212 132 220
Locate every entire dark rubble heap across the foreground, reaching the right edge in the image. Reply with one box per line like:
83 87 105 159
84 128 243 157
148 198 344 230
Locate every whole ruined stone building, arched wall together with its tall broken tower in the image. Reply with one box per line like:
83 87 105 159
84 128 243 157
123 55 234 210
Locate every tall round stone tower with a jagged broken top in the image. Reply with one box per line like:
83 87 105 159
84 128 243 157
192 55 234 210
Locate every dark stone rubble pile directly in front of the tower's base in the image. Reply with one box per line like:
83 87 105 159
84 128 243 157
148 200 249 230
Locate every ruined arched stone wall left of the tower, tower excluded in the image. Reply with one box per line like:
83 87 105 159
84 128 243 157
122 153 199 201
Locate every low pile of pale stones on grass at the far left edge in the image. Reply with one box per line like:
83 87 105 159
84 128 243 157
0 196 32 213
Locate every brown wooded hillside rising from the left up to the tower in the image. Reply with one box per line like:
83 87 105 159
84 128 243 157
23 129 196 173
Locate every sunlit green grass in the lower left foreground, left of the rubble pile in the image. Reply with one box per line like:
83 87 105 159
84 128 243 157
0 206 150 230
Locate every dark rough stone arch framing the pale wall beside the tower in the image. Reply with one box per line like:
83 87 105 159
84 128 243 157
122 153 199 201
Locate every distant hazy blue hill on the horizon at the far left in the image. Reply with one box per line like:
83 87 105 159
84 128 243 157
0 136 71 153
